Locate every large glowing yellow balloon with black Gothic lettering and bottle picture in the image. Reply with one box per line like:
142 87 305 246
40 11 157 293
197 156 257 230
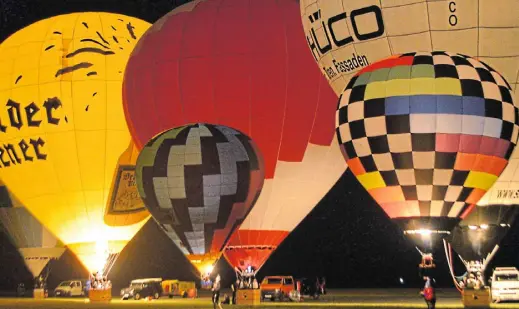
0 13 150 271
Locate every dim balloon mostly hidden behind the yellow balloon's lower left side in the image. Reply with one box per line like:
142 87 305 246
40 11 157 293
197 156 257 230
0 184 65 278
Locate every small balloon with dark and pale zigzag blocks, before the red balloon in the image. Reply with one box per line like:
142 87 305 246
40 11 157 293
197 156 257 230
137 124 265 281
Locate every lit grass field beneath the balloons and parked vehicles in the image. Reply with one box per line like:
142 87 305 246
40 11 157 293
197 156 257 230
0 289 519 309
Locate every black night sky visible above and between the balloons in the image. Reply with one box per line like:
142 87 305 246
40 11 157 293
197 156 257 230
0 0 519 291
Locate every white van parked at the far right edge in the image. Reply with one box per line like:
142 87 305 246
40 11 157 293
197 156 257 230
490 267 519 302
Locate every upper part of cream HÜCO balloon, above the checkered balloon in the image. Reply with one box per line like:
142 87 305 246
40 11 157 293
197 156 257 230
300 0 519 94
